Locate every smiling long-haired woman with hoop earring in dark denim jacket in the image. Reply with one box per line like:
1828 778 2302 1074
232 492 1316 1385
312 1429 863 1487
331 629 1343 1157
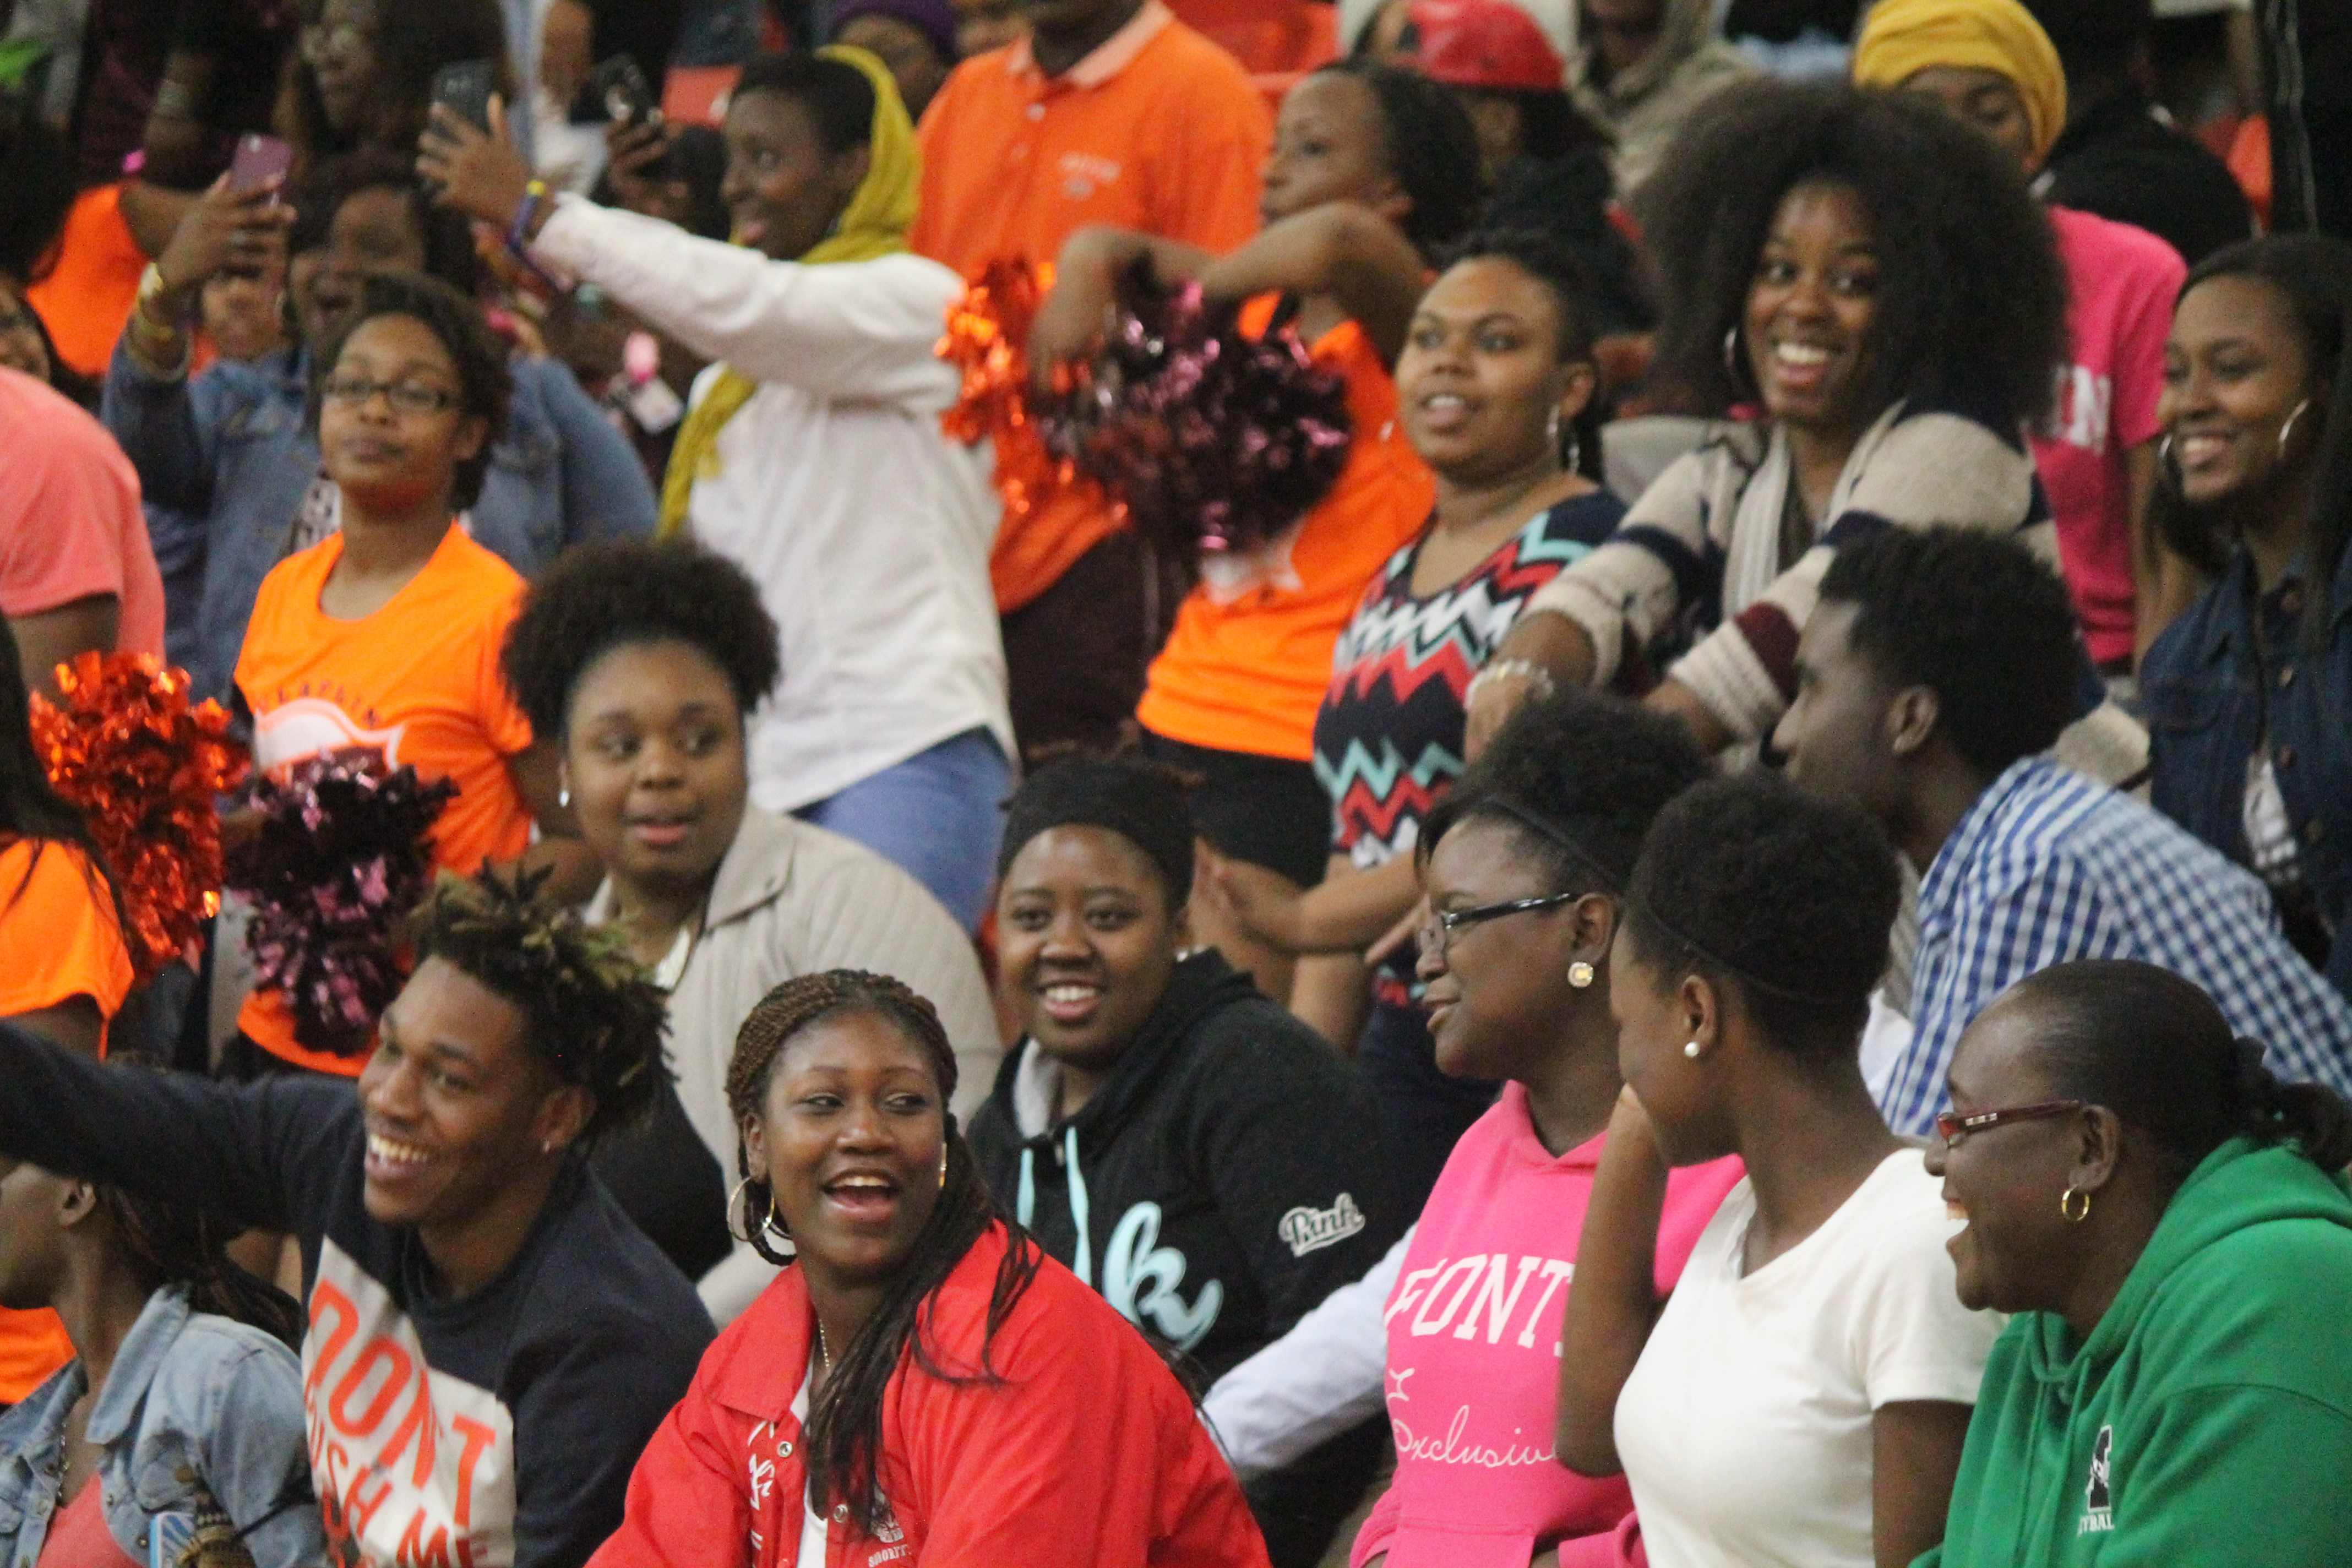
2143 235 2352 997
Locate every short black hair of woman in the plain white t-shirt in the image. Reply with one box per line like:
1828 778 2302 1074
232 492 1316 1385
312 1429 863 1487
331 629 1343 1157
1620 769 1903 1063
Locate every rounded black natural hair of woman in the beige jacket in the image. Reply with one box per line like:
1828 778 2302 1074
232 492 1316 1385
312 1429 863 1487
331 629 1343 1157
503 538 781 736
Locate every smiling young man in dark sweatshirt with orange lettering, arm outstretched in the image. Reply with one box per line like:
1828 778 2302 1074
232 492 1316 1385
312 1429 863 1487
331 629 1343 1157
0 874 710 1568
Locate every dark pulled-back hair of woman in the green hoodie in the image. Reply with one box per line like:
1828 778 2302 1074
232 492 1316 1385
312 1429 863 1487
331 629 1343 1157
2004 959 2352 1183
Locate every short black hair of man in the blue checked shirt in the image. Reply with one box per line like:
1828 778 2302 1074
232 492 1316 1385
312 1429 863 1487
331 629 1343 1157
1821 526 2089 778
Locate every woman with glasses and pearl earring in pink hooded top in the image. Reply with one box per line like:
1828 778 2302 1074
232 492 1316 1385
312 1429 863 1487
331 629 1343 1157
1350 694 1740 1568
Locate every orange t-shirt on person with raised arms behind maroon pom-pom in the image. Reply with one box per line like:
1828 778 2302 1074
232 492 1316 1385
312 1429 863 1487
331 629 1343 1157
1136 298 1437 761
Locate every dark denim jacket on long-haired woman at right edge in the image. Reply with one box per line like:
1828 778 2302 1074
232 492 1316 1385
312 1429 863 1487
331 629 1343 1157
2141 546 2352 994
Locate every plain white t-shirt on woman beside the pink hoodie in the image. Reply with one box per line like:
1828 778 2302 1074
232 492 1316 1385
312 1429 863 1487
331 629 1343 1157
1616 1150 2001 1568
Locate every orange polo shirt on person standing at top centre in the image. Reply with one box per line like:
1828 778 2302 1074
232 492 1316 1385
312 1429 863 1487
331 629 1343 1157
910 0 1275 611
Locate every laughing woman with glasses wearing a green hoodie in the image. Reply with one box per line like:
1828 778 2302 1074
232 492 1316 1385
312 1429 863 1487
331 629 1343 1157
1919 961 2352 1568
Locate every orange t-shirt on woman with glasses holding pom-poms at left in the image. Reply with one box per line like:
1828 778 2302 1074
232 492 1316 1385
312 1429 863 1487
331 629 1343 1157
237 524 531 1077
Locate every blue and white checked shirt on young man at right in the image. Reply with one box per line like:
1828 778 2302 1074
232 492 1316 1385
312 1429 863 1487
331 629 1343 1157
1879 757 2352 1135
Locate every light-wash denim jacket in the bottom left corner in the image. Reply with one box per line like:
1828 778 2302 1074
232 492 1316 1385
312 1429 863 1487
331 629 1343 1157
0 1286 327 1568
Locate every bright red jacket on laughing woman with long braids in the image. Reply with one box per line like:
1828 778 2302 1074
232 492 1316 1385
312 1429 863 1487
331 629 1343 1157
590 1225 1268 1568
